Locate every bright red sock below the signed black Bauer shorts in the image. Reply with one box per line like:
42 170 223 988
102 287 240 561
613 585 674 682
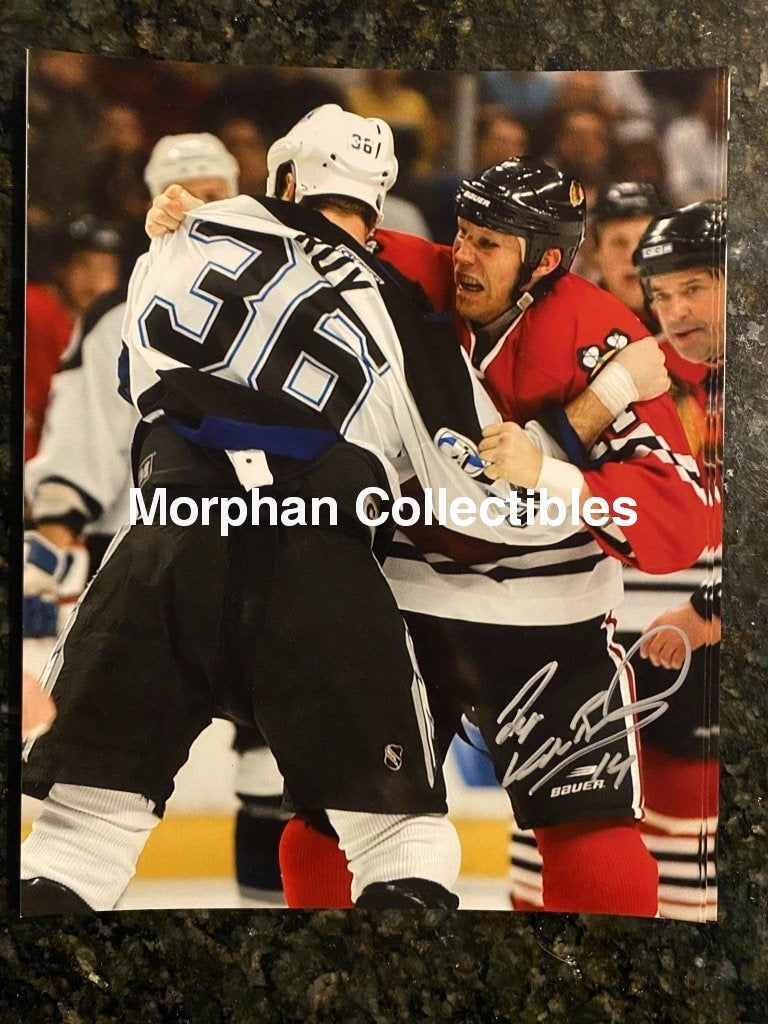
534 818 658 918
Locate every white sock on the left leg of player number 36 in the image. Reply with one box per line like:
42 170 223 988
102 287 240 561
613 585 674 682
20 783 160 910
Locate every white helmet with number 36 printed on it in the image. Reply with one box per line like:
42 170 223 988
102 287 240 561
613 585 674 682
266 103 397 220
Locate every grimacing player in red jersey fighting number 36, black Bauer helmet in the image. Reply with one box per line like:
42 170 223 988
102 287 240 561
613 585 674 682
384 159 707 915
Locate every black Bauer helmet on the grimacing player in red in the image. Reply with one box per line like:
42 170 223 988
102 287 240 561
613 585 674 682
456 157 587 281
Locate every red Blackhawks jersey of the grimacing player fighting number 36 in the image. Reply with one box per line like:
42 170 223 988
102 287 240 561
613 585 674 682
377 231 712 626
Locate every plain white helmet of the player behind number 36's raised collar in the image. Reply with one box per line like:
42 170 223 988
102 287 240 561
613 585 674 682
144 132 240 196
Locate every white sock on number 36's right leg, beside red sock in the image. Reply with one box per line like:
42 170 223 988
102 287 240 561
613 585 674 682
327 811 462 901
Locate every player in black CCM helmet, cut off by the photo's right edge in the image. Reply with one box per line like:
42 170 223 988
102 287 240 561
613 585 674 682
634 201 726 921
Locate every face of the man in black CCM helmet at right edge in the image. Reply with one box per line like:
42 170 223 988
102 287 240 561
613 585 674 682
650 268 725 362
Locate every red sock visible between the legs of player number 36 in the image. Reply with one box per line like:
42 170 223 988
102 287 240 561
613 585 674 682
280 817 354 910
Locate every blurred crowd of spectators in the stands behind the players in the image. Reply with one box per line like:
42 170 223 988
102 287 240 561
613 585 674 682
28 51 727 455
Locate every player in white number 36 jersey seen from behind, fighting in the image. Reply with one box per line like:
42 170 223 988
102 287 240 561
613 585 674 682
23 112 573 912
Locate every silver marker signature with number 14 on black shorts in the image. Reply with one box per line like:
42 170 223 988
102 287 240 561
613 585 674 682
496 626 691 795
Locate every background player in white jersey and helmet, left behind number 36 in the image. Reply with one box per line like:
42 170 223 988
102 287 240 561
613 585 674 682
23 133 296 900
